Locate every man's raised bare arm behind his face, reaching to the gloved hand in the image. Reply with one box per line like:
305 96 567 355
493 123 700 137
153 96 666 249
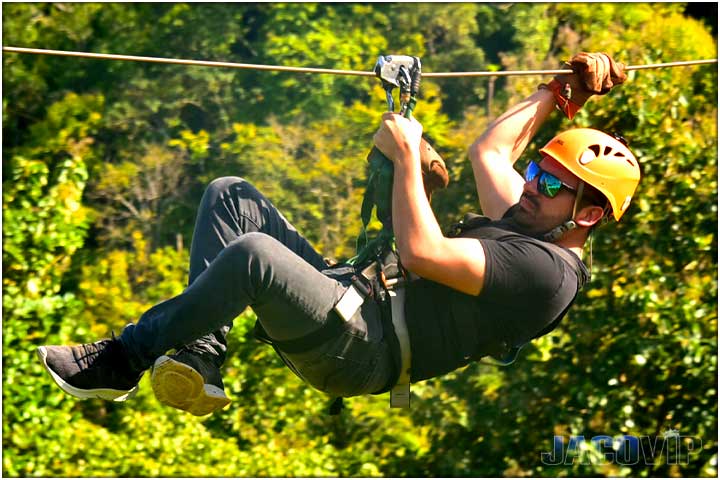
468 89 555 220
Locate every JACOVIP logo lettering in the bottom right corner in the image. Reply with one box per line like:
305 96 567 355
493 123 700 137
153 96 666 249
540 429 702 465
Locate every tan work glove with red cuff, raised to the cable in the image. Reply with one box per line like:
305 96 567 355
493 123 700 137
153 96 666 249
547 52 627 119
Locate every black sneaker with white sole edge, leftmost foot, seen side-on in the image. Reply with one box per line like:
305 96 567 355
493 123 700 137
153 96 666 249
37 336 143 402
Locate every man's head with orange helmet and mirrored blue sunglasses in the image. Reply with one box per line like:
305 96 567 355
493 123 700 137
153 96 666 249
513 128 640 240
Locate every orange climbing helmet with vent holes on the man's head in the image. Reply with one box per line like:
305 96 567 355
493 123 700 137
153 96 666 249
540 128 640 220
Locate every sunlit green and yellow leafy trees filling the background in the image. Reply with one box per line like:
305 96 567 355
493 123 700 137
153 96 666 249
2 3 718 477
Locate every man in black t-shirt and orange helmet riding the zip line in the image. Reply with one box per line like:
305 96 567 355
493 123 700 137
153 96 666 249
38 53 640 415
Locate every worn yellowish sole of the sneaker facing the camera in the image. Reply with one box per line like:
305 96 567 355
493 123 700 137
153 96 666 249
150 355 230 417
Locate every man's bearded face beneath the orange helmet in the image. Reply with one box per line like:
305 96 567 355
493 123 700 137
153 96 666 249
512 156 580 235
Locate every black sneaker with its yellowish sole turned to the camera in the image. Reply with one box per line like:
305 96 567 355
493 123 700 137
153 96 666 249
150 349 230 417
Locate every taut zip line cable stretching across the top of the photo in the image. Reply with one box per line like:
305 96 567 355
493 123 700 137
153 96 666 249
2 47 717 78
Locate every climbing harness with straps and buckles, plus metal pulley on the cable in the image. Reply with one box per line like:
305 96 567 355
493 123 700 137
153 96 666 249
254 55 421 414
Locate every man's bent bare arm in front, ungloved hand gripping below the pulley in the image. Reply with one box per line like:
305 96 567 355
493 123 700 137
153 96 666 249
375 113 485 295
